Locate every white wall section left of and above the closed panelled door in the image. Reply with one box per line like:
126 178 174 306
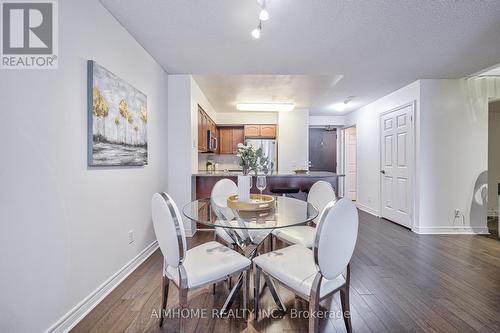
345 81 420 215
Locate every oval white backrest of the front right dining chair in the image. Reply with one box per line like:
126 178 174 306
313 198 358 279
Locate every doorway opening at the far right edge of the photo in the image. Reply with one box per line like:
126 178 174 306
488 98 500 239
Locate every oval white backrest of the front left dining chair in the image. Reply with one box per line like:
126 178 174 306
151 192 187 267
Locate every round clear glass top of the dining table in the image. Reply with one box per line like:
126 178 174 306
182 197 319 229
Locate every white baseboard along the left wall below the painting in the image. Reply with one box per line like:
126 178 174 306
45 240 158 333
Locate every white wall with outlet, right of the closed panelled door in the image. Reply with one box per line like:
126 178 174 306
417 78 500 233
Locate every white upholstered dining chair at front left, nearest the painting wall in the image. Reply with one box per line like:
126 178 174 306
151 193 251 332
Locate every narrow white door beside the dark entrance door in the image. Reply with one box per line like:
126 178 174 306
344 127 358 201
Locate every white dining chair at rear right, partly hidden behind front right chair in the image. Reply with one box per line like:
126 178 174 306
272 180 337 248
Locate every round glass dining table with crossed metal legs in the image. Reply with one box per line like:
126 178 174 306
182 196 319 315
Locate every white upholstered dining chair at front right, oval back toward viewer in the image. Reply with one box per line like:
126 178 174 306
253 198 358 333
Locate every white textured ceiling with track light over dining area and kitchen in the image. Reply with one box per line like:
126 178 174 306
101 0 500 115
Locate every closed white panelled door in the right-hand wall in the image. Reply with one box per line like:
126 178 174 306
380 104 414 228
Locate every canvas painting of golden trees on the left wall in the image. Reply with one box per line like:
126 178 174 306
87 60 148 166
